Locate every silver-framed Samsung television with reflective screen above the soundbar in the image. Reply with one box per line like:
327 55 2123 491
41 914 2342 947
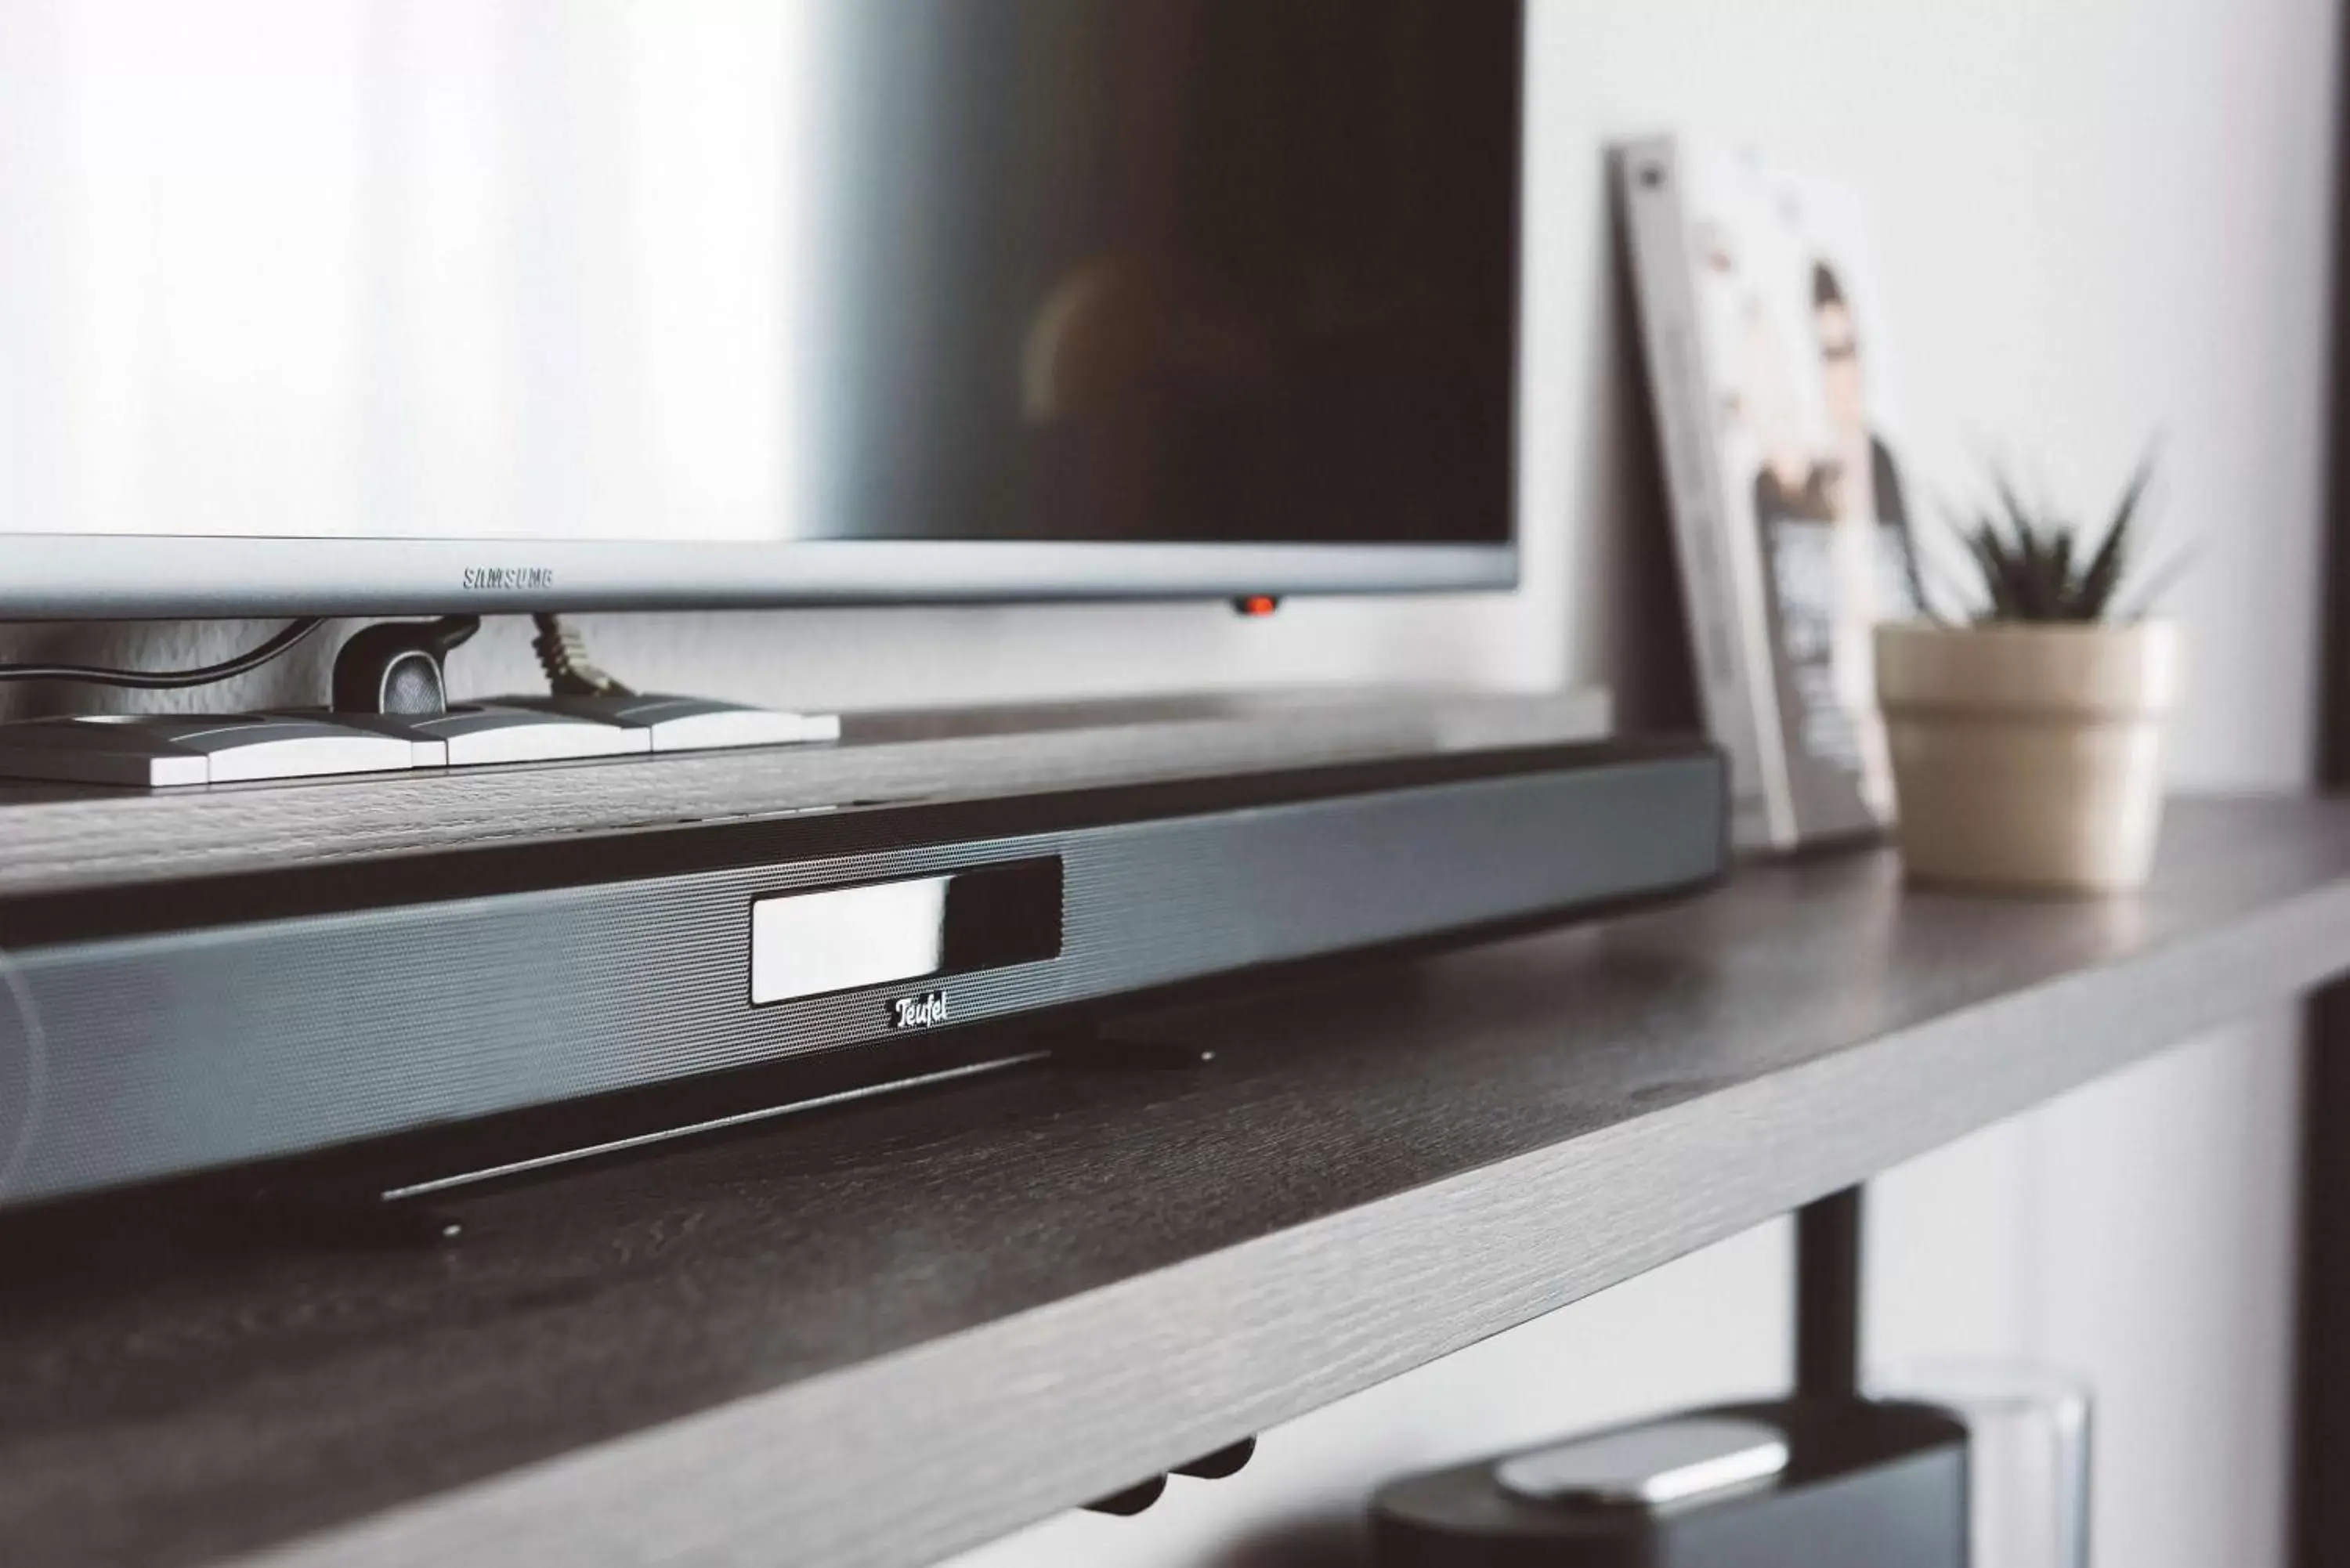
0 0 1525 618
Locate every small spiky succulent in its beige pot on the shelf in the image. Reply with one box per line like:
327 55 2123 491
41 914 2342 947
1875 458 2181 894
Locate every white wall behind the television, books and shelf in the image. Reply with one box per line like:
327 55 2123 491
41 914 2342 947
0 0 2336 1568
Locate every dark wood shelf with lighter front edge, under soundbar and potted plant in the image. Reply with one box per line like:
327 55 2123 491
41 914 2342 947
0 802 2350 1568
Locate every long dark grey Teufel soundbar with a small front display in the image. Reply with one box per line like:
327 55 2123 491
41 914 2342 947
0 740 1725 1206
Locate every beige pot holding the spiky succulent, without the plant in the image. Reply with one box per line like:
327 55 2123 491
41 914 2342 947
1878 620 2181 894
